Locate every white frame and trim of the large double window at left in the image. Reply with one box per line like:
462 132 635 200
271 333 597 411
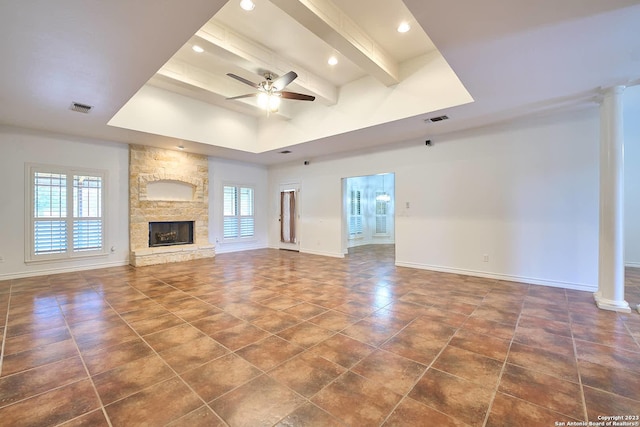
24 163 109 264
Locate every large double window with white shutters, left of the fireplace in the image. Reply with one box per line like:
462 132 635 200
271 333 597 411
27 165 106 261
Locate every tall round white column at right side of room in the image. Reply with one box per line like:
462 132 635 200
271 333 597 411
594 86 631 313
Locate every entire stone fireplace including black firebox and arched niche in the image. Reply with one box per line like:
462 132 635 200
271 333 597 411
129 145 215 267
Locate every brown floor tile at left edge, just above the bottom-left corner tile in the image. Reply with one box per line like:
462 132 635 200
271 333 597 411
0 357 88 407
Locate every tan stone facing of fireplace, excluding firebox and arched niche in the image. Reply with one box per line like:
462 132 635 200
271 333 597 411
129 145 215 267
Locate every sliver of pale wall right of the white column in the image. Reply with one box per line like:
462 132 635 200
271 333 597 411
623 85 640 267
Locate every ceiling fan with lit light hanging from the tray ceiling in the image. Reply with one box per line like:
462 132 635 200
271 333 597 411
227 71 316 111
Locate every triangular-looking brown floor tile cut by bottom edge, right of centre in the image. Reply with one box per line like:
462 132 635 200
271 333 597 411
383 397 468 427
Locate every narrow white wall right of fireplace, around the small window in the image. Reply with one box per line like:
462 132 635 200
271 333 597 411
209 158 269 253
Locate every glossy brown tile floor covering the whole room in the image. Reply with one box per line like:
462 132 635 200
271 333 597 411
0 246 640 427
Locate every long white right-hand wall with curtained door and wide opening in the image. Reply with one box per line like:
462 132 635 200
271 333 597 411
269 106 600 291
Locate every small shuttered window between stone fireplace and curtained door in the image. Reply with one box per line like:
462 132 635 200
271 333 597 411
222 185 255 239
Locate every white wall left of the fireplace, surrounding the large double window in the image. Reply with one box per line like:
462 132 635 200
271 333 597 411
0 126 129 280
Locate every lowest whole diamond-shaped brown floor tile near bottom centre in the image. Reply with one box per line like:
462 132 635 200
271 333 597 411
269 353 345 398
